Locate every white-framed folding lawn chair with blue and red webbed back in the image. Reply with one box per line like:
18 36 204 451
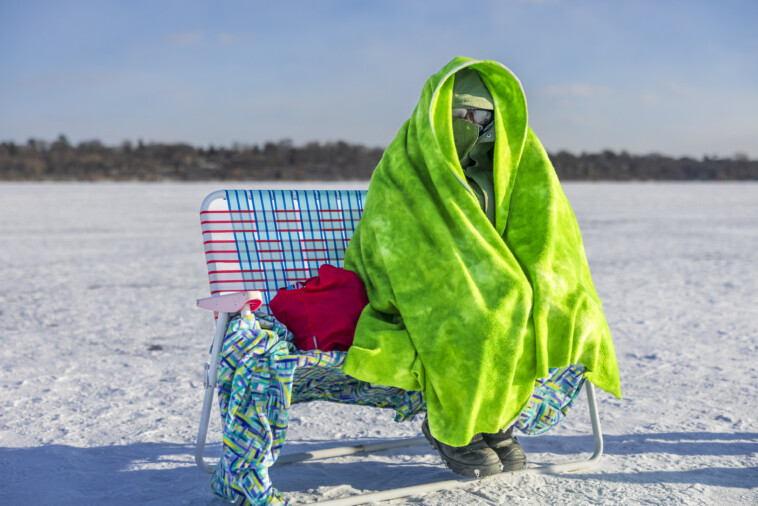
195 190 603 504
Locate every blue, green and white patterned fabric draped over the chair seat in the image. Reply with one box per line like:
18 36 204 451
211 312 584 505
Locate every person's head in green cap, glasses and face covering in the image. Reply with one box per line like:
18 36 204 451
451 68 495 159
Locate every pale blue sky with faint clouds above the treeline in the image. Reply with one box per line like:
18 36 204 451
0 0 758 158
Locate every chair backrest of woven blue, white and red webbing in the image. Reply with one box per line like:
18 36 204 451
200 190 366 310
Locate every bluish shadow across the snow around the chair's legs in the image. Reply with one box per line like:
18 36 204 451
0 432 758 505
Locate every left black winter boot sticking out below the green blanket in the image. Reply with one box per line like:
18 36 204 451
421 419 503 478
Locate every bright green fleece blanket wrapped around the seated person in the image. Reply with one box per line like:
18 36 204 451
343 58 620 446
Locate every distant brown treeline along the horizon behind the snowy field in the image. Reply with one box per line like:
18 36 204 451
0 136 758 181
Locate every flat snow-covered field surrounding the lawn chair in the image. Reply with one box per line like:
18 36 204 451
0 182 758 505
